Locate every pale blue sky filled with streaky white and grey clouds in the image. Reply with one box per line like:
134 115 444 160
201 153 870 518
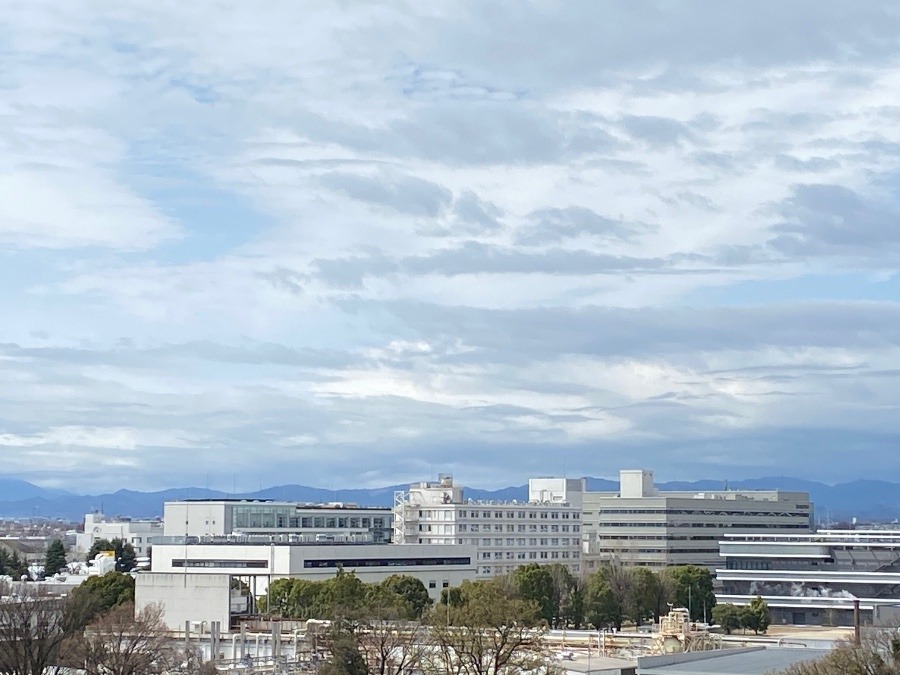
0 0 900 493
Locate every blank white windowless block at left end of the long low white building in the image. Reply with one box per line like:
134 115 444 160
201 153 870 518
134 572 231 630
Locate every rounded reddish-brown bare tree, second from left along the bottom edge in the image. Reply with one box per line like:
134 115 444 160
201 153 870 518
68 604 176 675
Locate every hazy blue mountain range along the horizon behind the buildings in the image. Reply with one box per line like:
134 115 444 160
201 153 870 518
0 477 900 522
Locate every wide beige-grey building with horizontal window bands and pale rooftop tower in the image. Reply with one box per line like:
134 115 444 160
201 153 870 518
582 469 813 571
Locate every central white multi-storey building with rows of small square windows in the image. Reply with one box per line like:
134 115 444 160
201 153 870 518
393 475 584 577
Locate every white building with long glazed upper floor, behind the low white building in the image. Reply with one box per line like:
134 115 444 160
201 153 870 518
163 499 391 544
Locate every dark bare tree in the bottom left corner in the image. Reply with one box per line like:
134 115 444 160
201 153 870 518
0 582 66 675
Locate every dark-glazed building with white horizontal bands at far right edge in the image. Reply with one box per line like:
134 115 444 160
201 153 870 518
716 530 900 626
